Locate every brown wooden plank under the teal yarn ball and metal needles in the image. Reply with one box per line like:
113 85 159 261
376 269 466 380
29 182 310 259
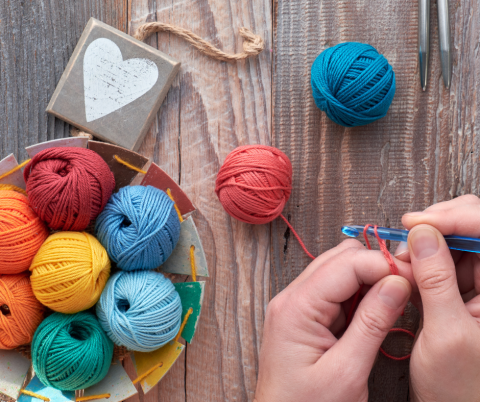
271 0 480 402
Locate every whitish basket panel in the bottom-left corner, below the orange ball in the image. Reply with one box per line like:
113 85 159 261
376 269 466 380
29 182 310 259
0 350 30 399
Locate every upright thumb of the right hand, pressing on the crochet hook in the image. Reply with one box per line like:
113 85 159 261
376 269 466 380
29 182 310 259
408 225 466 327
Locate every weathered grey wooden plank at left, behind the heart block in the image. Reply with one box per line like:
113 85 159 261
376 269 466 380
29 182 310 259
0 0 127 162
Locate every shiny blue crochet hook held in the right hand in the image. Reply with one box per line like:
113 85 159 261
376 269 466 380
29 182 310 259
342 225 480 253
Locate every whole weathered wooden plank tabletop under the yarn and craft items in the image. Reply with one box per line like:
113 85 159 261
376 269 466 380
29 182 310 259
0 0 480 402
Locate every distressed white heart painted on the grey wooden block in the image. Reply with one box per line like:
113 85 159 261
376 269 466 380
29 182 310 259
83 38 158 122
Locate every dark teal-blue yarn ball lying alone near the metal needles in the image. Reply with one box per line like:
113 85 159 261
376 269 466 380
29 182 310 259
312 42 395 127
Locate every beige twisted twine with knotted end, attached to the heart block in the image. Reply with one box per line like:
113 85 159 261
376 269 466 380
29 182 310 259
134 22 265 62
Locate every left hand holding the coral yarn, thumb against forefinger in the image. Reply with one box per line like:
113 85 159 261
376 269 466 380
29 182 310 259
255 240 413 402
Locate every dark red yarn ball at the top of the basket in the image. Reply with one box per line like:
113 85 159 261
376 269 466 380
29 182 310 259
23 147 115 231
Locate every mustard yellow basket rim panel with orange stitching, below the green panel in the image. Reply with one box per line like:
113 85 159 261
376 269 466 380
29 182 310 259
132 341 185 393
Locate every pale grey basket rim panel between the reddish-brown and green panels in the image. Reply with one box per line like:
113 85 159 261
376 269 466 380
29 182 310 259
160 216 208 276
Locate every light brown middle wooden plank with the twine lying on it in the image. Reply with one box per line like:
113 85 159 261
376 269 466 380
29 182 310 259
121 0 271 402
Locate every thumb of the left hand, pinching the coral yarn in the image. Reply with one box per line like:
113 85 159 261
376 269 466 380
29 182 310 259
331 275 412 373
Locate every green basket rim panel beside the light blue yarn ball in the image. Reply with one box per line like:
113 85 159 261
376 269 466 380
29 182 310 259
173 282 205 343
